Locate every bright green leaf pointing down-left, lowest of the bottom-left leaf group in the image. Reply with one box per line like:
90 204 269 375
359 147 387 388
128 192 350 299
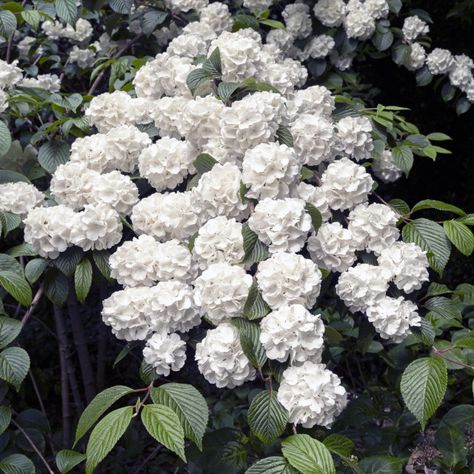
86 407 133 474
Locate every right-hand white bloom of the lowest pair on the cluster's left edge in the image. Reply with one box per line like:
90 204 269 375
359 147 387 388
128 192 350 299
71 204 122 251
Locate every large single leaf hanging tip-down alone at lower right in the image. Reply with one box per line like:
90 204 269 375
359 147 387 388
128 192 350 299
400 357 448 430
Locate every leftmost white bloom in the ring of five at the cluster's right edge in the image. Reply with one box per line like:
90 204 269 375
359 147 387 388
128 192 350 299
308 222 357 272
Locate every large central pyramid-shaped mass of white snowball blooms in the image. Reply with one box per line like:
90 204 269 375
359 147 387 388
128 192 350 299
17 0 439 428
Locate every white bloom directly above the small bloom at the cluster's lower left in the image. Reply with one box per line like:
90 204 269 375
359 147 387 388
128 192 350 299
146 280 201 333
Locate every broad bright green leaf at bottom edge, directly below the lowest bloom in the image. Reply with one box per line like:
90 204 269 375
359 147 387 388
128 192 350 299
281 434 336 474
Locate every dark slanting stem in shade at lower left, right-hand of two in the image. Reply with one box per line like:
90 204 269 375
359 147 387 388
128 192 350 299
68 286 96 403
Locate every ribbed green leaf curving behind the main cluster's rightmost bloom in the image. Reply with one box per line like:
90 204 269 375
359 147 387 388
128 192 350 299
402 218 451 275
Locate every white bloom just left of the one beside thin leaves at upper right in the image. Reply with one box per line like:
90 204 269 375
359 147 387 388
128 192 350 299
290 114 335 166
